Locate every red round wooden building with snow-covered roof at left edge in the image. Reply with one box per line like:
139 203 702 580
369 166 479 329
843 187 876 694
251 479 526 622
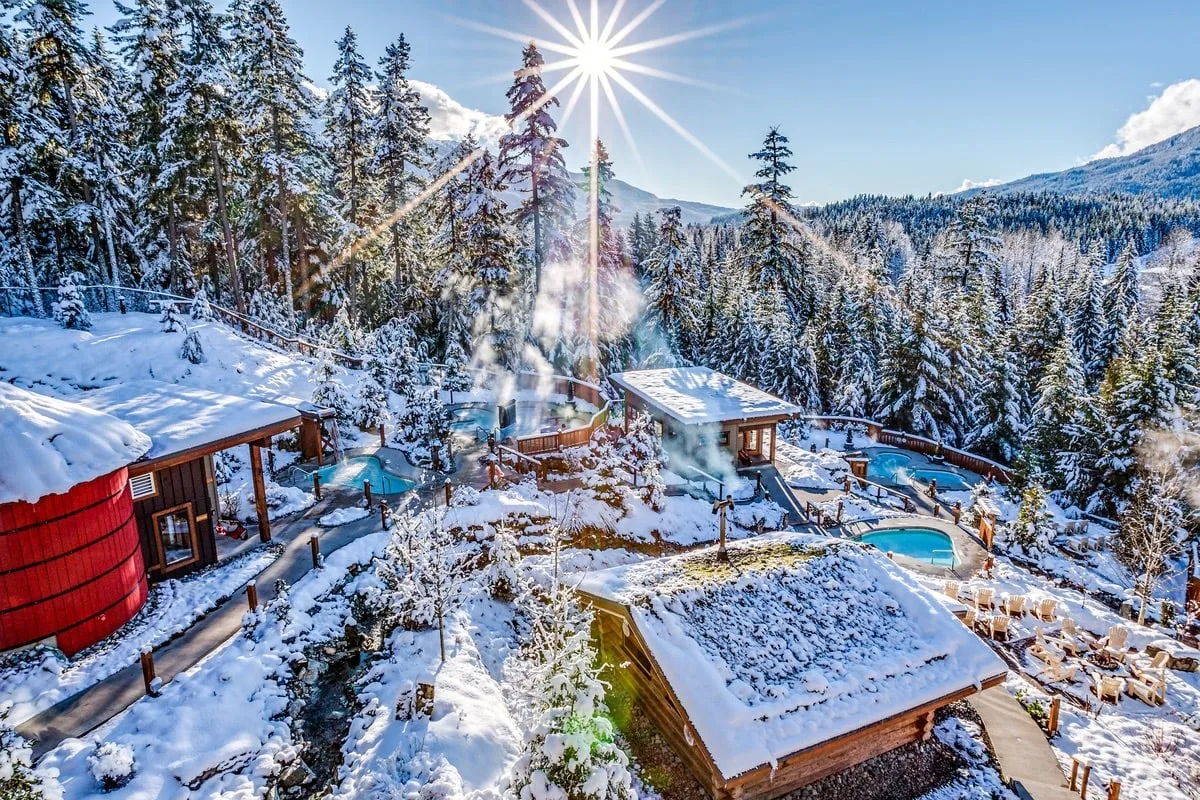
0 384 149 656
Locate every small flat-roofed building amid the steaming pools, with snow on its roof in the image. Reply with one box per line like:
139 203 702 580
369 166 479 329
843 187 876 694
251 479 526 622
610 367 803 467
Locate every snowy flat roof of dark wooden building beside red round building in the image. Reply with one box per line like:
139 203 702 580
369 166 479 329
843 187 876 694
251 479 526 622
79 380 300 458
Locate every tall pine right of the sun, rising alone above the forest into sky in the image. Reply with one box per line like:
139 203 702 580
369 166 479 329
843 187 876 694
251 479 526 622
740 127 816 327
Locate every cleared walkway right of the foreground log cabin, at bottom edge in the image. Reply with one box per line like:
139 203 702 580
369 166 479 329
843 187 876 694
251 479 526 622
967 686 1076 800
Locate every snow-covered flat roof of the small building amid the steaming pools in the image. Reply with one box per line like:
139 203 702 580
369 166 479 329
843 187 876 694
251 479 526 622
610 367 804 425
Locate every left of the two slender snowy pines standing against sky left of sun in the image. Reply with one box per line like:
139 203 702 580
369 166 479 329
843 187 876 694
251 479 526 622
325 26 380 302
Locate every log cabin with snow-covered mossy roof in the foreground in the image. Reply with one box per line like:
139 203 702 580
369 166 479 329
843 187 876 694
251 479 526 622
578 533 1007 800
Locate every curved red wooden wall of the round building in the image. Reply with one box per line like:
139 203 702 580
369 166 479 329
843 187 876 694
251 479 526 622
0 468 146 656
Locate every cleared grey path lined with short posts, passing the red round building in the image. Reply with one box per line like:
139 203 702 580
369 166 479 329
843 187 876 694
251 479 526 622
17 492 393 757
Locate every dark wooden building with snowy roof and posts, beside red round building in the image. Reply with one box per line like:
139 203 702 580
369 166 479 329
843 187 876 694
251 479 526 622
79 380 301 582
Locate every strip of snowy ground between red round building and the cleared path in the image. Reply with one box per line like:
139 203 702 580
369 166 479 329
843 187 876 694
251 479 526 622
0 547 280 724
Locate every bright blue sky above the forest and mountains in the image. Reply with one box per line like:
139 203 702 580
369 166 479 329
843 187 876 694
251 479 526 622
92 0 1200 205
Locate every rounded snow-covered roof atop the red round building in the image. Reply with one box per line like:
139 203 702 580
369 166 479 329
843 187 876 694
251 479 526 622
0 383 150 503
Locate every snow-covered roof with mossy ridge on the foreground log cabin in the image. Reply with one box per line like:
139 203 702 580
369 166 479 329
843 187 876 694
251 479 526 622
578 531 1006 780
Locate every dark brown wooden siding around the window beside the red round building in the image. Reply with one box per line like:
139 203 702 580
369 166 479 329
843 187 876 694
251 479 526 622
133 456 217 581
